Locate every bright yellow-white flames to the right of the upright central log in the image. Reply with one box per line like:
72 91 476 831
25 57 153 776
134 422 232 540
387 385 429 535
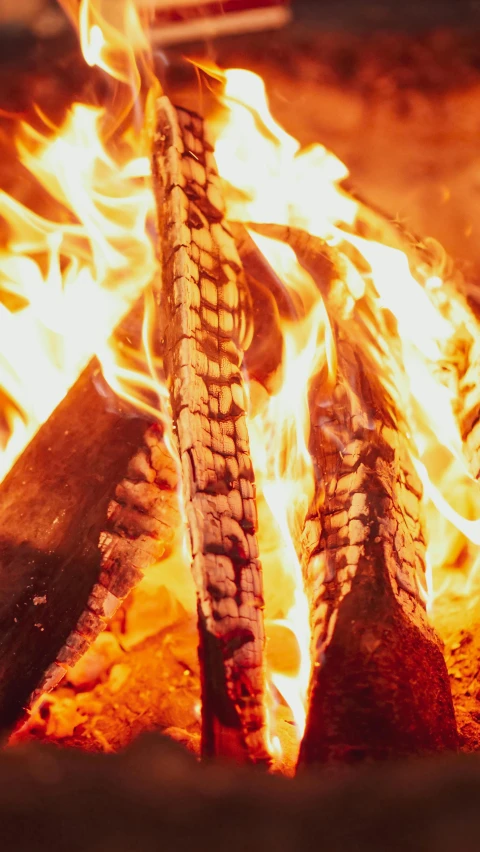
212 68 480 760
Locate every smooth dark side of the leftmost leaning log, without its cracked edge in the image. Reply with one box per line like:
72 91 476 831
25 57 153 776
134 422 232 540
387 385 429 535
0 361 154 729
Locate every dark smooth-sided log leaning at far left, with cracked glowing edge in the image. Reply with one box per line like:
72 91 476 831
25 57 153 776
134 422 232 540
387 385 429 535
0 350 177 731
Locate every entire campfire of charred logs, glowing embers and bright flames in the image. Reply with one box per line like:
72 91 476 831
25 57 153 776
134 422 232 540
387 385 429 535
0 0 480 772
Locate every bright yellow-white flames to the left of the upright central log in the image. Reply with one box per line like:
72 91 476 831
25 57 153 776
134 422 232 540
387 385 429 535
0 0 161 476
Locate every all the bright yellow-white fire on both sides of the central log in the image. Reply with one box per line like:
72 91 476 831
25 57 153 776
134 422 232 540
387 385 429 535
0 0 480 764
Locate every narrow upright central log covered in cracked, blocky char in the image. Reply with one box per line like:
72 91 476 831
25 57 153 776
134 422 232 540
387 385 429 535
153 98 268 761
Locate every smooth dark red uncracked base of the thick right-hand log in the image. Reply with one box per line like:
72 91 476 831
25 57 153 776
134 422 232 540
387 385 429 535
299 564 457 765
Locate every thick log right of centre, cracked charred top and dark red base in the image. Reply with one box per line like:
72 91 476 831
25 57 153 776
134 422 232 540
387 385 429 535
251 229 456 764
